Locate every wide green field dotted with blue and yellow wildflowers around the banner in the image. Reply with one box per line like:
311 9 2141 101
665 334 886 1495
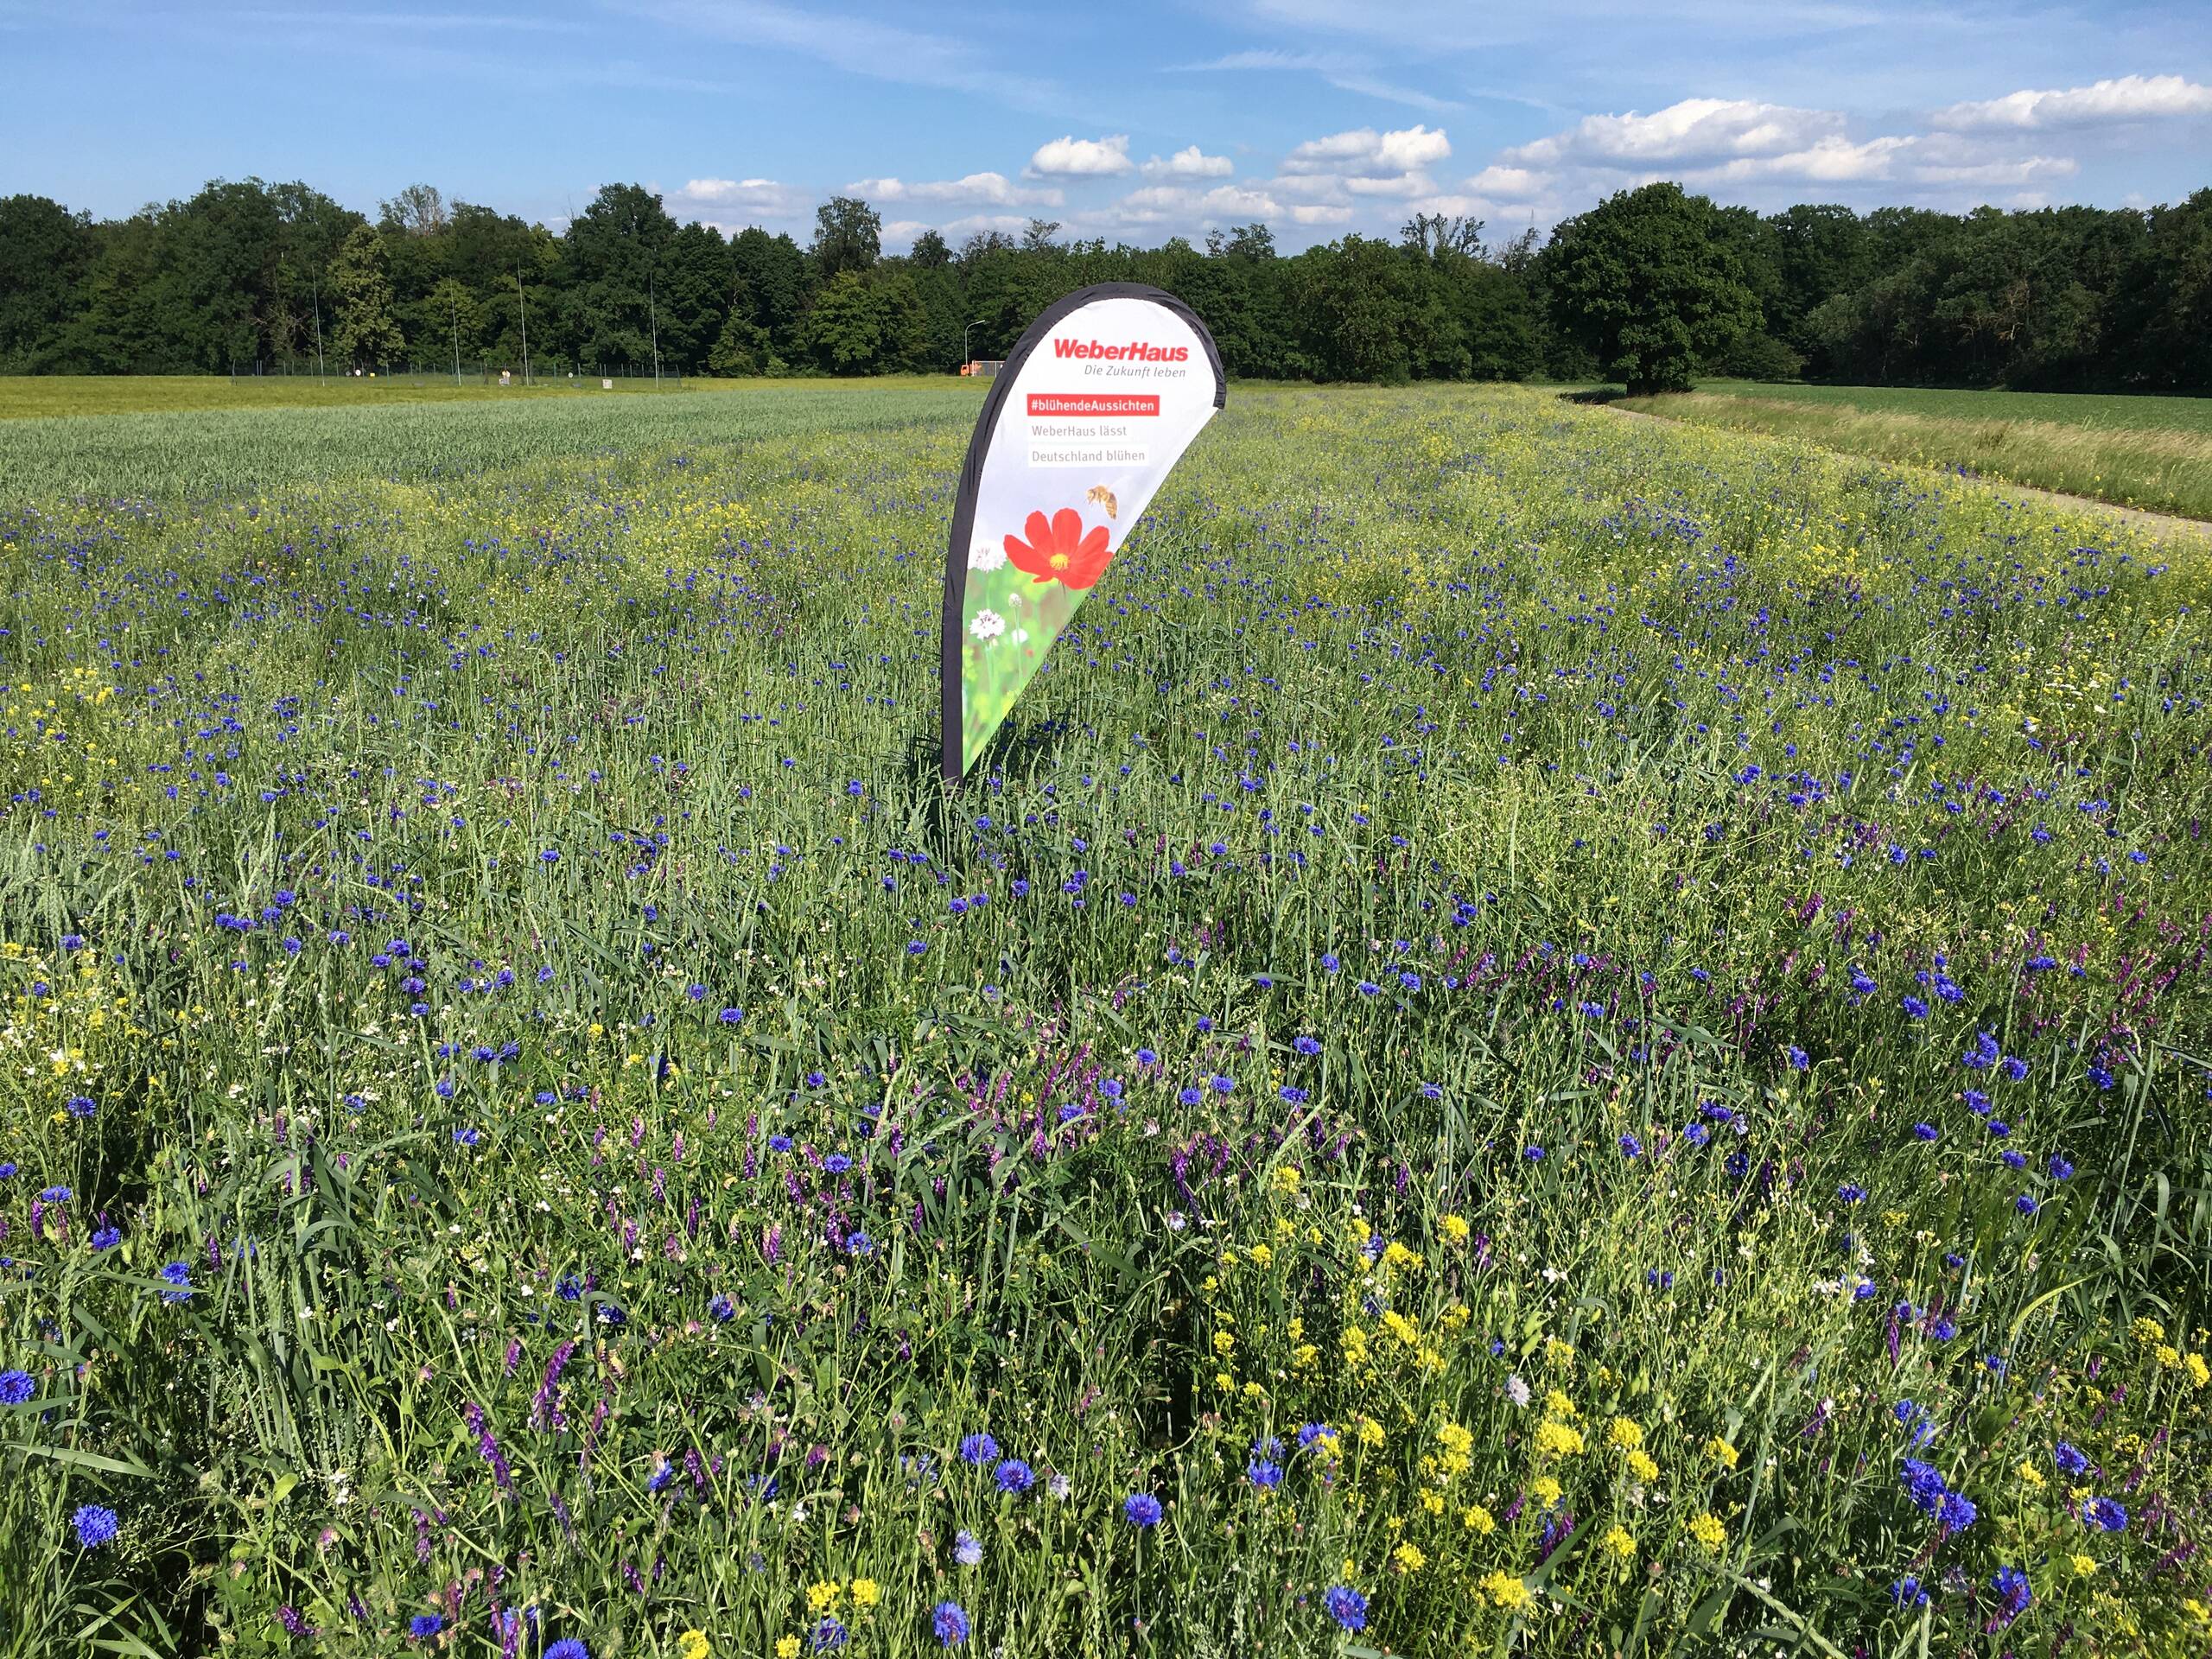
0 385 2212 1659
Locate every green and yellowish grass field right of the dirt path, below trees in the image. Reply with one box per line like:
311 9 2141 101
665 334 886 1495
1621 380 2212 518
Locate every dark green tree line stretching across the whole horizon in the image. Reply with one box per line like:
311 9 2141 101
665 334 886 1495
0 179 2212 391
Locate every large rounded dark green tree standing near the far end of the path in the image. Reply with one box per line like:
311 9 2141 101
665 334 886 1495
1546 183 1758 396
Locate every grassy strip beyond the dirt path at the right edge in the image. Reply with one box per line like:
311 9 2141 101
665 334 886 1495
1617 391 2212 518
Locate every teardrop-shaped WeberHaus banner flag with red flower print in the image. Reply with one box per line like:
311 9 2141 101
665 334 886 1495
940 283 1228 783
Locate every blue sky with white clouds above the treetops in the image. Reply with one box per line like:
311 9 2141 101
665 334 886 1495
0 0 2212 248
